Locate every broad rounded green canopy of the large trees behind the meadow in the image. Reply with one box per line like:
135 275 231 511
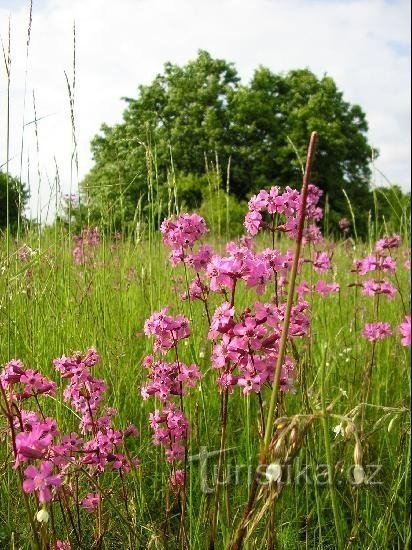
82 50 377 234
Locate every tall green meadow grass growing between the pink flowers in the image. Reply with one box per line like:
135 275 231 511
0 209 410 548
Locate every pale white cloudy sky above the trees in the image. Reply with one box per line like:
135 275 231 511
0 0 411 221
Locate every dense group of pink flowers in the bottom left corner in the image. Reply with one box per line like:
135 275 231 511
0 348 139 508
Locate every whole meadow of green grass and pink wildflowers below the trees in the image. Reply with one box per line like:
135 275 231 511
0 135 411 549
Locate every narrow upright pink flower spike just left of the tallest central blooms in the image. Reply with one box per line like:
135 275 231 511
141 308 201 493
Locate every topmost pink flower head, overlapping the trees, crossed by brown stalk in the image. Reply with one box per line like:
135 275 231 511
244 185 323 242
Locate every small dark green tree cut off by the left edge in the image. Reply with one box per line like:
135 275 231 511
0 170 29 231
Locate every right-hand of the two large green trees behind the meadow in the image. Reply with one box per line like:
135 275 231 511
232 67 376 224
